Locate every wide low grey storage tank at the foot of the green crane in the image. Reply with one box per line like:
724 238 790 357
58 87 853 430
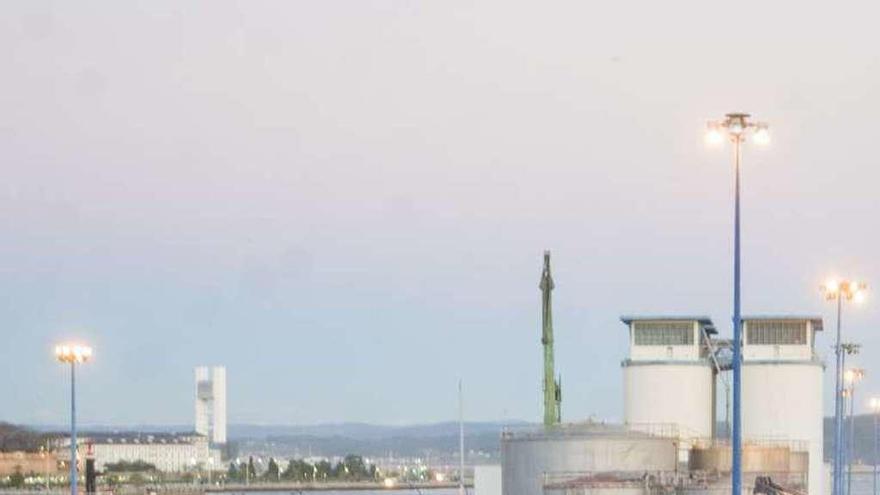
501 423 678 495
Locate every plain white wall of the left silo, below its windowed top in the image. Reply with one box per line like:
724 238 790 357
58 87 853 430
623 362 715 438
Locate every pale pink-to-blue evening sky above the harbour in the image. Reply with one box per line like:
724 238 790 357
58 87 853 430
0 0 880 425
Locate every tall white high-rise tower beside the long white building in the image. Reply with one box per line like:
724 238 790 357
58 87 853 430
196 366 226 445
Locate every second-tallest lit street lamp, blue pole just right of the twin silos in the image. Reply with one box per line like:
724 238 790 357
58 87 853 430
821 279 867 495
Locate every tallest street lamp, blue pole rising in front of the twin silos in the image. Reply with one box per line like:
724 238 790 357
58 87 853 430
706 113 770 495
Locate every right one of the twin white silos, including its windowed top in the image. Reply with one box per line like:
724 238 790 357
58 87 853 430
742 316 824 495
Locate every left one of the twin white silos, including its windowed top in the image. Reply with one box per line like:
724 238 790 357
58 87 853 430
621 316 716 454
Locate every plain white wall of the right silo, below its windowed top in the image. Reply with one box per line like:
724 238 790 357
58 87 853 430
742 361 825 495
